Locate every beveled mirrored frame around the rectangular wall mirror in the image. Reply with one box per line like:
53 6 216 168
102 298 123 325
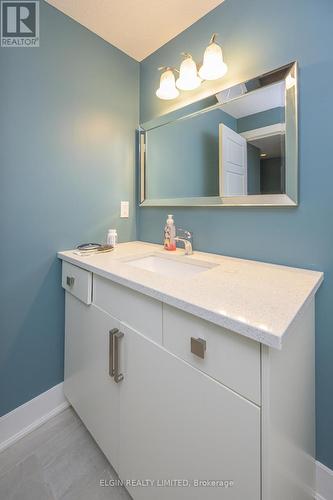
138 62 298 207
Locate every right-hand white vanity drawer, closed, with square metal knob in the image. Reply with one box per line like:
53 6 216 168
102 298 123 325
163 304 260 405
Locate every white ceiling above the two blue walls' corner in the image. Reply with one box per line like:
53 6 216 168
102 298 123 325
46 0 224 61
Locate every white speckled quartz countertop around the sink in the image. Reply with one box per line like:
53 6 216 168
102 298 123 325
58 241 323 349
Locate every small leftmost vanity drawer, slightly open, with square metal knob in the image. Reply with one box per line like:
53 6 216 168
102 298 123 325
62 261 92 304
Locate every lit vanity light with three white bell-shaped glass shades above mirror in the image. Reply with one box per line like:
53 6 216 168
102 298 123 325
156 33 228 100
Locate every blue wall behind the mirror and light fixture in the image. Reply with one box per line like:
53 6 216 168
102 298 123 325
138 0 333 467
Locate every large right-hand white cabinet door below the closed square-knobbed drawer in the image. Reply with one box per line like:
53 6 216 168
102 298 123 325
119 325 260 500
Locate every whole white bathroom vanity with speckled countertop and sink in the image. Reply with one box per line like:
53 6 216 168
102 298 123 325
58 242 323 500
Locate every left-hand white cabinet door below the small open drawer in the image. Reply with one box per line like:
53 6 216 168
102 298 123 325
64 293 120 469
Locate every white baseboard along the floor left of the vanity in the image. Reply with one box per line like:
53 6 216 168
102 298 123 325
0 383 69 452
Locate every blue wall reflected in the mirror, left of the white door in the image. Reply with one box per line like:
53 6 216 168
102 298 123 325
146 109 237 199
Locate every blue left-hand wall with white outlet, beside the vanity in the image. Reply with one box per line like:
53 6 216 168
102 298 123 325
0 2 139 414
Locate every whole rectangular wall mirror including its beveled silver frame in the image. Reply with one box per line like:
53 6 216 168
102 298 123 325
139 63 298 206
